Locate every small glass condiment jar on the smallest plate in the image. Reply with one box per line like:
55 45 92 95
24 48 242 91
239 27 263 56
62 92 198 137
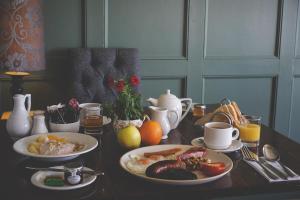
64 162 83 185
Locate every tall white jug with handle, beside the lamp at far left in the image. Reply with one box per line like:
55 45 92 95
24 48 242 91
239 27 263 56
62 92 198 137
6 94 31 140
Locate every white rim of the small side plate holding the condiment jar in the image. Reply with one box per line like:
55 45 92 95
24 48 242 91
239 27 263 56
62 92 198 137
30 166 97 190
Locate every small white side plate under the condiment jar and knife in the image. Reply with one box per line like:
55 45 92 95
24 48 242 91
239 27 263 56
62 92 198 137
31 166 97 190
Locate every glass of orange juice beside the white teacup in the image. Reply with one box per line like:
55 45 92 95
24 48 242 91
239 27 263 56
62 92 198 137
238 115 261 149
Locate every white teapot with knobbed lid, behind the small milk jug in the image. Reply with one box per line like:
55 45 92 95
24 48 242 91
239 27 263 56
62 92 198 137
147 89 192 129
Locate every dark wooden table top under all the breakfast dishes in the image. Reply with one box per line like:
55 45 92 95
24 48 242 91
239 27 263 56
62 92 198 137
0 116 300 200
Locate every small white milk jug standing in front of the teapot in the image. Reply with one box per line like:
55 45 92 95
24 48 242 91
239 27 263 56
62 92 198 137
149 106 171 139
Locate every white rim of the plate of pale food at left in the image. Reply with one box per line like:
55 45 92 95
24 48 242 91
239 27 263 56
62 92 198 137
13 132 98 159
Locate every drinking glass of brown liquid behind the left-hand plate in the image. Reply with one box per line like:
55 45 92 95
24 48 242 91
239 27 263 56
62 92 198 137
83 106 103 134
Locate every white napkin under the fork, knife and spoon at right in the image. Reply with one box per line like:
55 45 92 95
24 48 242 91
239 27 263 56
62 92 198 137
244 158 300 183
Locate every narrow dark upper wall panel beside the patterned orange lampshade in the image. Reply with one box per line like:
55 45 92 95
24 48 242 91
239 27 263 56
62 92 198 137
43 0 83 51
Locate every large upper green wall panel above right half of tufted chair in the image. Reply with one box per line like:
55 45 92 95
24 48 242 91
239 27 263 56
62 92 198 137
108 0 187 59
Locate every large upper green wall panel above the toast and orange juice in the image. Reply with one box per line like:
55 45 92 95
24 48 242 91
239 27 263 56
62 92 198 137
205 0 278 57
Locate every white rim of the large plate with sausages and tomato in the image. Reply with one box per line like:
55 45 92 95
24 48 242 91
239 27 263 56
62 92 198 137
119 144 233 185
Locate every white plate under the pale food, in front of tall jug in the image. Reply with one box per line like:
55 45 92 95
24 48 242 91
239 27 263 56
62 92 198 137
13 132 98 161
